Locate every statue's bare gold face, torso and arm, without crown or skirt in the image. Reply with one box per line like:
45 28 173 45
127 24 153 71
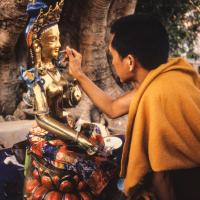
29 12 97 154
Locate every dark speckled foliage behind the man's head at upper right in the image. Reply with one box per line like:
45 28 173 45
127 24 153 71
136 0 200 58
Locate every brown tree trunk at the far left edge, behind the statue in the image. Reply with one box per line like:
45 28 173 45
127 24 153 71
0 0 27 115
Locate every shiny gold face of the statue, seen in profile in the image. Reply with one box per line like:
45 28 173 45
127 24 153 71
40 25 61 60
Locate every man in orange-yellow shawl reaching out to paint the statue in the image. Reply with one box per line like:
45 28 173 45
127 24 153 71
66 14 200 200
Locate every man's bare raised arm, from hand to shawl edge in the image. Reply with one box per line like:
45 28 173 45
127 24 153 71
66 47 134 118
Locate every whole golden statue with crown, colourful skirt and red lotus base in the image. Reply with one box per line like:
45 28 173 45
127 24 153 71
22 0 116 200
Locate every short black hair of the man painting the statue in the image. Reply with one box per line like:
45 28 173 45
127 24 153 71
111 14 169 70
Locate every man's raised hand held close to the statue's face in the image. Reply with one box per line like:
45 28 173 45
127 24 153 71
66 47 83 80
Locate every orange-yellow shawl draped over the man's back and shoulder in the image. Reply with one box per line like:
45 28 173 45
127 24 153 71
121 58 200 194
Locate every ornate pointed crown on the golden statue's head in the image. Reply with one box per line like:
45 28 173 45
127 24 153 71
26 0 64 46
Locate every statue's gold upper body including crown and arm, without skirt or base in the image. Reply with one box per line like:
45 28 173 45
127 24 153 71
23 0 97 154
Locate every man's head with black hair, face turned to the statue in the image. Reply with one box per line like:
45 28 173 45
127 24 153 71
109 14 169 81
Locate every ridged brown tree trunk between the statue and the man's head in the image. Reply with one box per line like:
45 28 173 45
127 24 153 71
73 0 136 129
